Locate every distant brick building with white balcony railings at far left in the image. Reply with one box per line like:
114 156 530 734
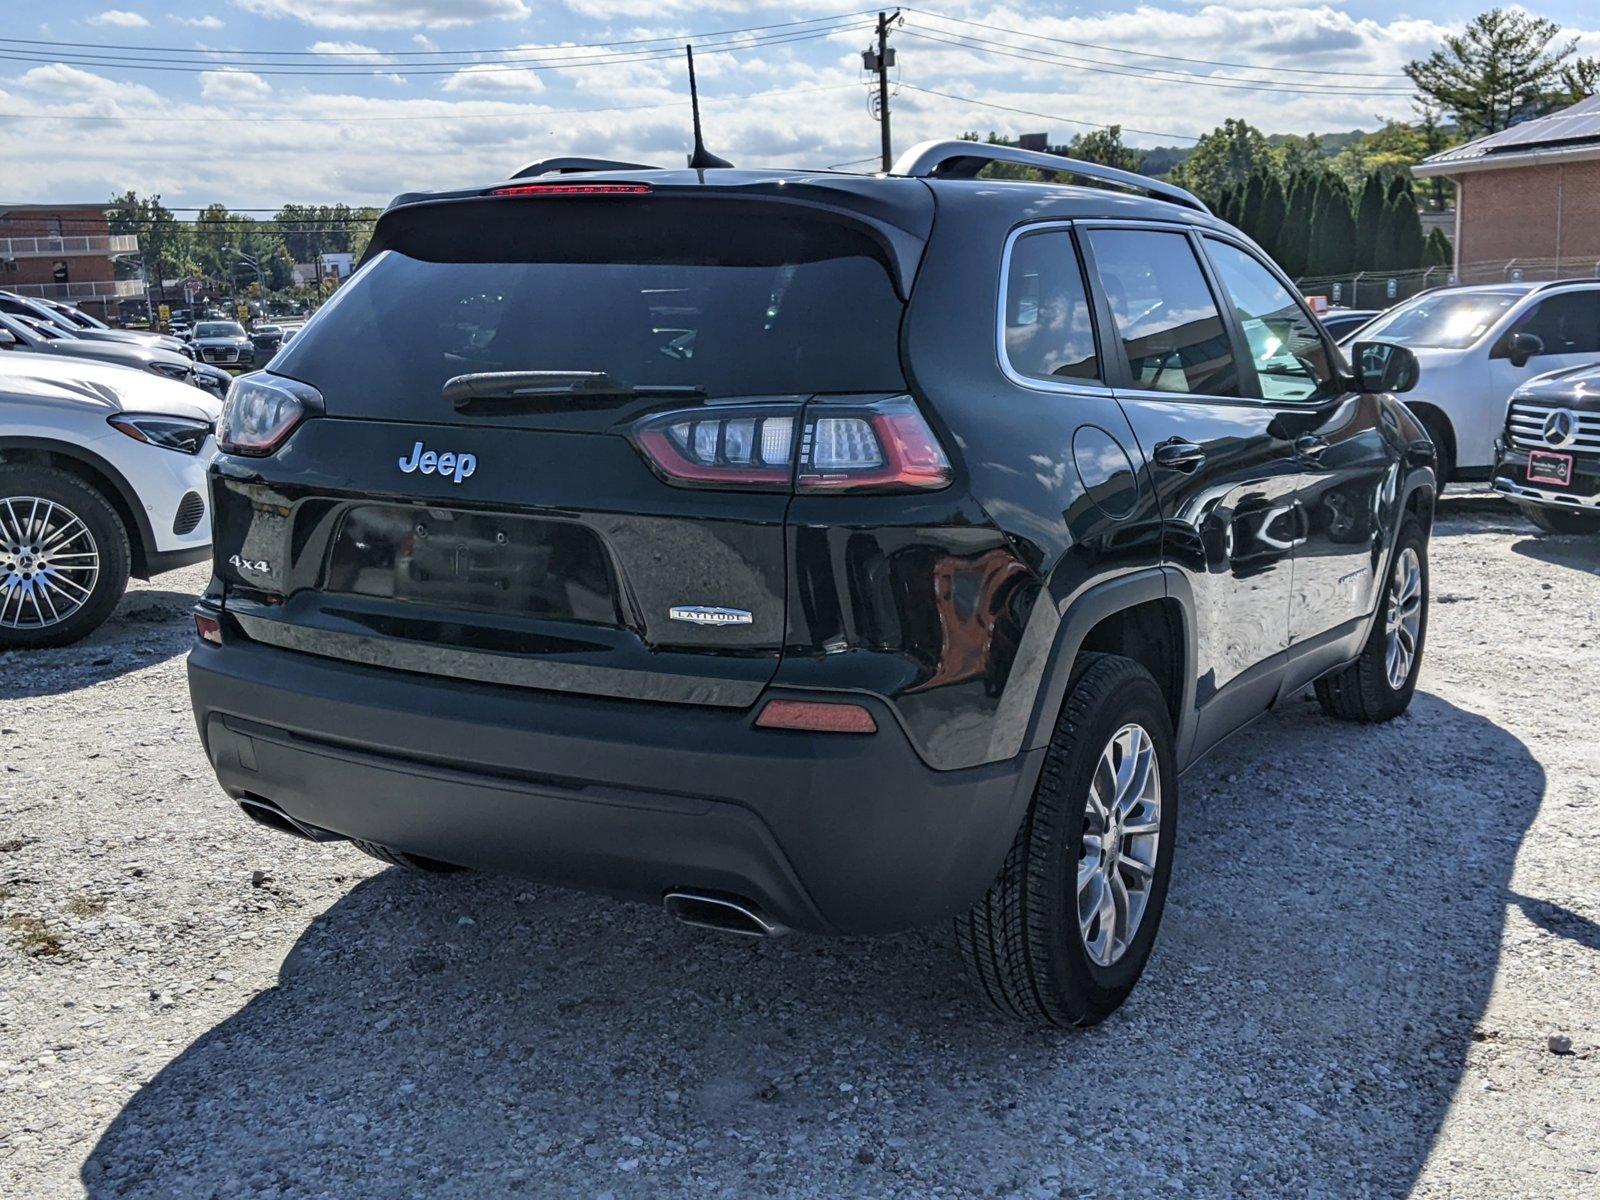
0 203 144 318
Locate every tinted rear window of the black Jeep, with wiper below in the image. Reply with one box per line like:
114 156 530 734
272 214 904 401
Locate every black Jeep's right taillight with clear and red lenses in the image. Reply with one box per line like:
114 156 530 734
630 395 952 493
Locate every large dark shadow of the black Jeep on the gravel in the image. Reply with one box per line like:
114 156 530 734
82 694 1544 1200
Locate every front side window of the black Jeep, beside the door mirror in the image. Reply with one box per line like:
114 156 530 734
1206 238 1339 402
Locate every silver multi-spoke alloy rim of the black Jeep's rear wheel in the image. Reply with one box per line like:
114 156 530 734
1078 725 1162 966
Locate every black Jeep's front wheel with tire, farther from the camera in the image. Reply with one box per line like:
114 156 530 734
1317 515 1427 725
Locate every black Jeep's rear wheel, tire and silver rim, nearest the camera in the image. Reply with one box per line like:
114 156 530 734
955 654 1178 1026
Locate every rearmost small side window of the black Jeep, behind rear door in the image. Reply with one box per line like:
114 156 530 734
1005 229 1101 379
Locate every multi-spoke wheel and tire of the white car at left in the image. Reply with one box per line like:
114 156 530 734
0 462 133 650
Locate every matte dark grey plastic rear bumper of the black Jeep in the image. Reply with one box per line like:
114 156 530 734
189 640 1043 933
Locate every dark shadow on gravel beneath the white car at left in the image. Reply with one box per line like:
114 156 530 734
0 587 195 699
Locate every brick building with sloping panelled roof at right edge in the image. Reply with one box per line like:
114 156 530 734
1411 96 1600 282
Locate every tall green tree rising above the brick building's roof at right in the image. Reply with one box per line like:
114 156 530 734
1405 8 1578 138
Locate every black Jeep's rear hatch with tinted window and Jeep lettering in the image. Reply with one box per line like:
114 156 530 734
216 189 928 706
